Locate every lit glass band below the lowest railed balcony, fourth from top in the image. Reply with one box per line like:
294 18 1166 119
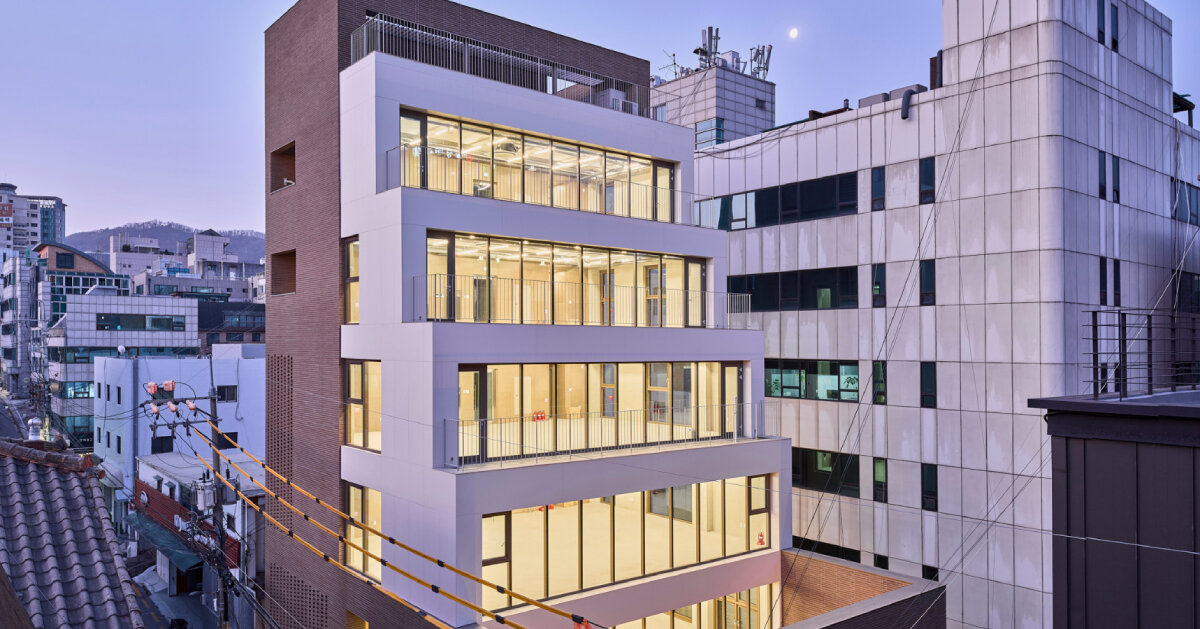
482 475 772 609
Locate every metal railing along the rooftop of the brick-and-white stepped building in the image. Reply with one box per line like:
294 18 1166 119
350 16 650 118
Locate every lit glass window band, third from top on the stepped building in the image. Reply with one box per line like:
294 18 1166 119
450 363 749 465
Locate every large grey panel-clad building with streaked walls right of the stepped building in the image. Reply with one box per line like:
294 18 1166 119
695 0 1200 628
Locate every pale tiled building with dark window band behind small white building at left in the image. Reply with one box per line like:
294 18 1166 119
39 292 199 450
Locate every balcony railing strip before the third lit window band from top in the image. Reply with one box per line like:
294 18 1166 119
443 402 780 471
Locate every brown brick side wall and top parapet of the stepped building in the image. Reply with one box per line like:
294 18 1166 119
263 0 649 628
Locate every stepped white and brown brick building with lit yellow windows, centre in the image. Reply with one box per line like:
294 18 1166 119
266 0 792 628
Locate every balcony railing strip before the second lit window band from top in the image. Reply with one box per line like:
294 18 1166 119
412 275 750 330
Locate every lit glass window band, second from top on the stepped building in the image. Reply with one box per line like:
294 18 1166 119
425 233 707 328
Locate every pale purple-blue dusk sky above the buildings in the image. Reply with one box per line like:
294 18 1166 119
0 0 1200 233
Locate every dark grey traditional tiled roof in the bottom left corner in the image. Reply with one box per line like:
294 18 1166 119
0 439 144 628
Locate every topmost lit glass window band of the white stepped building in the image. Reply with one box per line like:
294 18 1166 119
389 113 674 222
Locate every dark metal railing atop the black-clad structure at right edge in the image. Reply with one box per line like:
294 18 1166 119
1082 307 1200 399
